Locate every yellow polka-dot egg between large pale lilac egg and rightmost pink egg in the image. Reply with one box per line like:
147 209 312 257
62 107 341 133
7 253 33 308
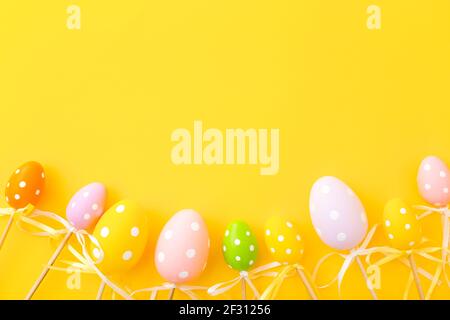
383 199 422 250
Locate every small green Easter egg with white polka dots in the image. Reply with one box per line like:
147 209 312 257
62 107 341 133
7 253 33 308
222 221 258 271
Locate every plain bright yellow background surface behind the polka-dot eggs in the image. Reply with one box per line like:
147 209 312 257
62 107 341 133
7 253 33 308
0 0 450 299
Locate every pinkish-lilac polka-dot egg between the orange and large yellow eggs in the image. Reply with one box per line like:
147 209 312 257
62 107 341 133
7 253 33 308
66 182 106 230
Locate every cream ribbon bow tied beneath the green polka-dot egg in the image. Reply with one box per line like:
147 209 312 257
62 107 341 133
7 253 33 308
208 262 281 299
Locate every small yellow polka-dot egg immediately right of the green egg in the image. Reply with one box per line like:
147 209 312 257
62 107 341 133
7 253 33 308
265 216 304 263
